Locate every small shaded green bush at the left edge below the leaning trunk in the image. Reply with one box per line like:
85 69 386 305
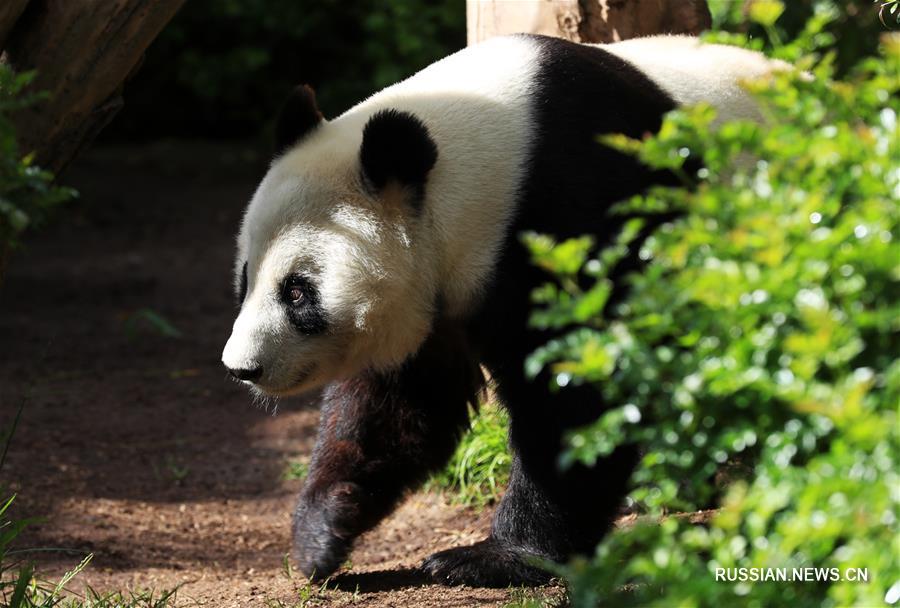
0 63 74 276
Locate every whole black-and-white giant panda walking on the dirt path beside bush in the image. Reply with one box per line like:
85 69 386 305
222 35 784 586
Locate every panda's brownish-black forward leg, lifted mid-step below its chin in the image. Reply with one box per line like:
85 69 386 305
293 326 482 579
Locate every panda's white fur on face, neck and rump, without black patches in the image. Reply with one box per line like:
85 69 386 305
222 36 781 394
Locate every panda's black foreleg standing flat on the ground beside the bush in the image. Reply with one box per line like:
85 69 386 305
423 373 637 587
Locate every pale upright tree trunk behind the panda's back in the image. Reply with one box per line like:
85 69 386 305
466 0 712 44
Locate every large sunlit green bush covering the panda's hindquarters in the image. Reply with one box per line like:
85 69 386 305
526 11 900 606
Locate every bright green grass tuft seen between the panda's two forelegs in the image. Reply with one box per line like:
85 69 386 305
427 403 512 507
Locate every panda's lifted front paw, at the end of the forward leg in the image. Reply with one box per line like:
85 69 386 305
293 482 361 580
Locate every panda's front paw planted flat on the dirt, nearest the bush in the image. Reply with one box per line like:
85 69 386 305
422 538 551 587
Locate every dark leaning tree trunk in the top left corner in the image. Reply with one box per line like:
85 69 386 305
0 0 184 173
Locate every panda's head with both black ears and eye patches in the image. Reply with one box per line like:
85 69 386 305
222 87 437 395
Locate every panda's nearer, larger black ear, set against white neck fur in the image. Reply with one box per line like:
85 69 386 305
359 110 437 196
